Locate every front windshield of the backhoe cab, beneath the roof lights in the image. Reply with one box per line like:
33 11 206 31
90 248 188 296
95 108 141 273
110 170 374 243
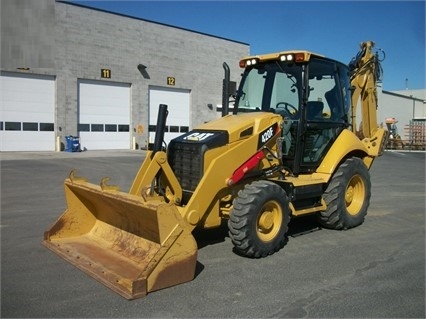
235 61 302 117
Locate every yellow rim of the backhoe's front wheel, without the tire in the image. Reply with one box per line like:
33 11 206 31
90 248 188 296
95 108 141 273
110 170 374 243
256 201 283 242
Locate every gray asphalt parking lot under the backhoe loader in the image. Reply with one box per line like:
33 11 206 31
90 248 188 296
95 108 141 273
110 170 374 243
1 151 425 318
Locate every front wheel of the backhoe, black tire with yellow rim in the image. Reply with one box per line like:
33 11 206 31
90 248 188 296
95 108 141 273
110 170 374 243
228 181 290 258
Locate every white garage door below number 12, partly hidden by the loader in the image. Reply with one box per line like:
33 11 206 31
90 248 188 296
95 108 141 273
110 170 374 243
149 87 190 148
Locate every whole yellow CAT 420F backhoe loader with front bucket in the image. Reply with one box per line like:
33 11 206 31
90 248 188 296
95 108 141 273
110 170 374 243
43 41 386 299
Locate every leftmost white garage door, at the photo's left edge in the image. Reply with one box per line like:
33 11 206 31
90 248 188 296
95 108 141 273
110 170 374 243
0 72 55 151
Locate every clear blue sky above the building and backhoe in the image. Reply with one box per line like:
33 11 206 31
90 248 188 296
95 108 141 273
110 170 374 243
72 0 426 91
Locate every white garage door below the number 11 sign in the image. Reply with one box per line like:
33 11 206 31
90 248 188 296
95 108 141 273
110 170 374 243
78 80 131 150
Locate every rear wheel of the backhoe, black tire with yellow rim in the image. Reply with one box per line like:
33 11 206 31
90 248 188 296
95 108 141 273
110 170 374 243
319 157 371 229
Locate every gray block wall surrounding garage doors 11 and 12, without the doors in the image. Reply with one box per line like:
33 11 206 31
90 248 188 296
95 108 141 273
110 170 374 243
56 2 249 146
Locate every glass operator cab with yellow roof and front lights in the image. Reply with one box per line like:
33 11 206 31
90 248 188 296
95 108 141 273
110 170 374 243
234 51 351 175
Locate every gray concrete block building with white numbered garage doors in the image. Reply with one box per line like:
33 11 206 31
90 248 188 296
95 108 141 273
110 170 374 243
0 0 250 151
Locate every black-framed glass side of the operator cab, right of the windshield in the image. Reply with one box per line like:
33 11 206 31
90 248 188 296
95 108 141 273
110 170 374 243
283 58 350 175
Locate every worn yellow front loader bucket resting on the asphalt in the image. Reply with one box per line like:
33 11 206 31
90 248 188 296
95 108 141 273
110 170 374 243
43 179 197 299
